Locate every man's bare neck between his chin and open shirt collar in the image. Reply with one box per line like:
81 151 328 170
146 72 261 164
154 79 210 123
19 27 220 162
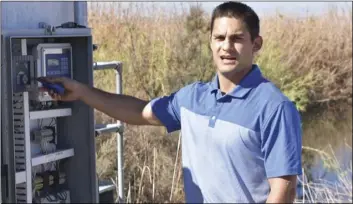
218 66 252 93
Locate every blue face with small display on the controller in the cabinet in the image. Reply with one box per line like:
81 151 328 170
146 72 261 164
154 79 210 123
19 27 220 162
45 52 71 77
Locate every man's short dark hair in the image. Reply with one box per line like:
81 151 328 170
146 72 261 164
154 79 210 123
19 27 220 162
211 1 260 41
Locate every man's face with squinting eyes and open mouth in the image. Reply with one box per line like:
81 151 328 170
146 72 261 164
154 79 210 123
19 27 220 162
211 17 258 75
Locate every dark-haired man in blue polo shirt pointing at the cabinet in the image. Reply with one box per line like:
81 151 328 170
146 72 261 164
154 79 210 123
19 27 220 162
40 2 302 203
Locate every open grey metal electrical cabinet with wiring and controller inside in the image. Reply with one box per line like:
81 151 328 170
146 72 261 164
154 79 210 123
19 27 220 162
1 28 98 203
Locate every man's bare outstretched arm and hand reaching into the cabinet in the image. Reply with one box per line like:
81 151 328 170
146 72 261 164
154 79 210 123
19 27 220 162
43 78 162 125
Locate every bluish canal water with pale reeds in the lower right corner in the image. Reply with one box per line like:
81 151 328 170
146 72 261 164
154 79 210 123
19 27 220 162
297 144 353 203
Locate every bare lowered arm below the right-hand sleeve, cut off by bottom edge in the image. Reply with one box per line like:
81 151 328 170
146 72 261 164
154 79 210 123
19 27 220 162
266 175 297 203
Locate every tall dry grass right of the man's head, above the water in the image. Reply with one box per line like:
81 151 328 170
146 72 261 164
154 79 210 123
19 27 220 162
257 7 352 111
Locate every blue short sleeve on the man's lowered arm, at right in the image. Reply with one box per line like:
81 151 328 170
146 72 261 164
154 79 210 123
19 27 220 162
261 101 302 178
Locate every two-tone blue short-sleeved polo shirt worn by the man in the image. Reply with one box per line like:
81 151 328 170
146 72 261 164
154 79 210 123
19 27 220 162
151 65 302 203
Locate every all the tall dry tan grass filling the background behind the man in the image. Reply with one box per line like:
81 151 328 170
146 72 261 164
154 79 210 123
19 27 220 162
89 2 352 202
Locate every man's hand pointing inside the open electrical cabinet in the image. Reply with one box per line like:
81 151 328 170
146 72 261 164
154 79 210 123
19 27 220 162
40 77 85 101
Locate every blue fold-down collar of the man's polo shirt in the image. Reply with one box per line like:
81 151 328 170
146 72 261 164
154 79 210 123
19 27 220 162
210 64 262 98
